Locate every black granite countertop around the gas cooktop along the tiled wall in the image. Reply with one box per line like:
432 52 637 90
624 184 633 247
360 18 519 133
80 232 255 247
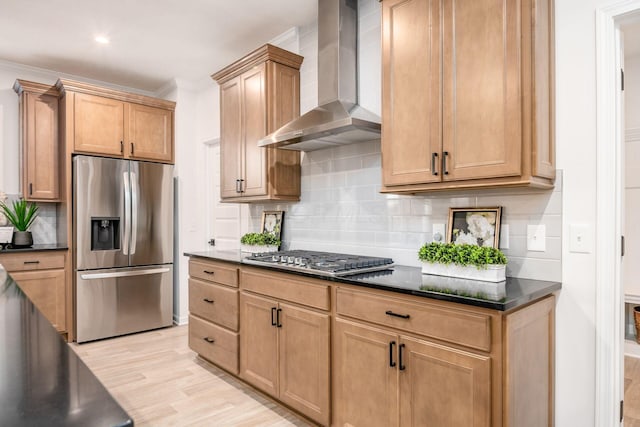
184 250 562 311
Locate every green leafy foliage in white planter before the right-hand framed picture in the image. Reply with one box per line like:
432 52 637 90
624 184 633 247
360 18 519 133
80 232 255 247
418 242 507 270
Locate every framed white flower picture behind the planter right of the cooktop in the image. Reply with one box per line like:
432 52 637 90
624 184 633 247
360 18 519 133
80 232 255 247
447 206 502 248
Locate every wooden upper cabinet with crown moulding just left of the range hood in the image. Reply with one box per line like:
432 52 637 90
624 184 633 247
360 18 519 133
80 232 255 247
212 44 302 202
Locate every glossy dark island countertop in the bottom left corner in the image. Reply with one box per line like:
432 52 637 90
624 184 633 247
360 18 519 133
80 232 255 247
0 269 133 427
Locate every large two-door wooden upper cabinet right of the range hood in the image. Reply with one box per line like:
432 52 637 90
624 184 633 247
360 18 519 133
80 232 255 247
382 0 555 193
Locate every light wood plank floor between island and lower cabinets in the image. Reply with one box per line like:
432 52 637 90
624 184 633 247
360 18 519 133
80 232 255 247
70 326 311 427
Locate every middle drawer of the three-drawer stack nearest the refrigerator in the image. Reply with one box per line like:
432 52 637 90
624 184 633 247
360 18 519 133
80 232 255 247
189 279 238 332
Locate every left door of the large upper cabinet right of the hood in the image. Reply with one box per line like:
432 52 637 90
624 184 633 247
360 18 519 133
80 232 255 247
382 0 442 185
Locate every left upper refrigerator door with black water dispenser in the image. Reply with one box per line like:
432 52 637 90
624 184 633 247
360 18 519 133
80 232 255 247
73 156 130 270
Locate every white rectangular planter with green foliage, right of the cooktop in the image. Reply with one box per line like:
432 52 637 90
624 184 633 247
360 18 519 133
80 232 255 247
418 242 507 282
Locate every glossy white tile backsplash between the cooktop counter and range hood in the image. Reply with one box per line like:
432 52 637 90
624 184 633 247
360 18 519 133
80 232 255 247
249 142 562 281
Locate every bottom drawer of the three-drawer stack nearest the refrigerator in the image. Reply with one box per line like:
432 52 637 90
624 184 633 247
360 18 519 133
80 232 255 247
189 316 238 375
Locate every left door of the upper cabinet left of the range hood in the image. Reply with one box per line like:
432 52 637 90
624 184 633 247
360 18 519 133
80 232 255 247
220 77 242 199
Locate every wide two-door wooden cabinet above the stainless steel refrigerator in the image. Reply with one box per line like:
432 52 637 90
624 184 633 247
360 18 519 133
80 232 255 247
56 79 175 163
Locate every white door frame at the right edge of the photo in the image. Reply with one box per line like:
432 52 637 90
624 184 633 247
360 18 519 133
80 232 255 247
595 0 640 426
